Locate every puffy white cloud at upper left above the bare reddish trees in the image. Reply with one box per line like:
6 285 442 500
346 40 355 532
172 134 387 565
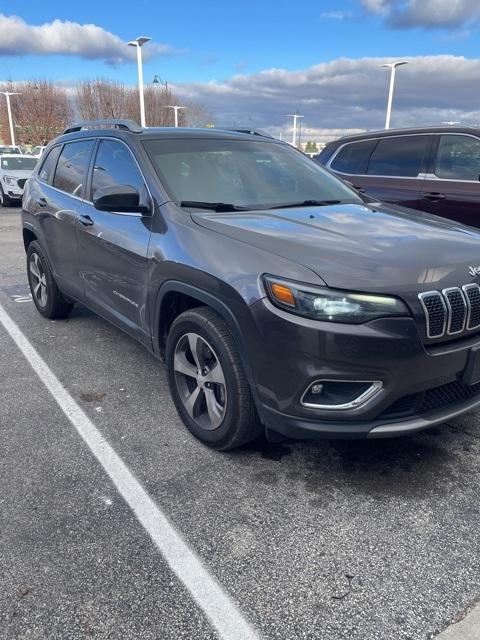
0 14 175 64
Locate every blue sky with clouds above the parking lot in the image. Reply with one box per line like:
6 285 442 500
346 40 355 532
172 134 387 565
0 0 480 141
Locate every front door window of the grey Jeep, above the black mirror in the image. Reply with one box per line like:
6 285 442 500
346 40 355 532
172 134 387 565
92 140 145 200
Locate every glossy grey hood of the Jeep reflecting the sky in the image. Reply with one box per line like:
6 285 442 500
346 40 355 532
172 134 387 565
192 203 480 293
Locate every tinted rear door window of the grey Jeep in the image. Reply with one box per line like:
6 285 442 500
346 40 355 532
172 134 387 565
53 140 93 198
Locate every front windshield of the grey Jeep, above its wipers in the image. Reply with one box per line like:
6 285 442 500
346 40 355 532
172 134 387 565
144 138 362 209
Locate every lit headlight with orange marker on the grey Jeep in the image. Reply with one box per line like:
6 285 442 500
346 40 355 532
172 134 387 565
264 276 410 324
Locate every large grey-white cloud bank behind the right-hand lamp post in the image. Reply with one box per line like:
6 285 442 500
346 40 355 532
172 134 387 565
172 55 480 140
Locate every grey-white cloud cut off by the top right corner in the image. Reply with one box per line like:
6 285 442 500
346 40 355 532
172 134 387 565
361 0 480 29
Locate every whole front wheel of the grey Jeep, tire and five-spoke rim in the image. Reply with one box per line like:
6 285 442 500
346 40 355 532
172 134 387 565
165 307 263 450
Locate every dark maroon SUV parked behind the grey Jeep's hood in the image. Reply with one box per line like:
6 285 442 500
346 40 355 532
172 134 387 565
315 127 480 227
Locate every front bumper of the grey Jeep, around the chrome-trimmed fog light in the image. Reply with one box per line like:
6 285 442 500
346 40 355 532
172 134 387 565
250 299 480 438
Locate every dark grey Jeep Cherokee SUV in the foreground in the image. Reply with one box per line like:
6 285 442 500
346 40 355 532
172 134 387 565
23 121 480 449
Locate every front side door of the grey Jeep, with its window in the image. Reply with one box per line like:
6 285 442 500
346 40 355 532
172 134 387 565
77 138 152 342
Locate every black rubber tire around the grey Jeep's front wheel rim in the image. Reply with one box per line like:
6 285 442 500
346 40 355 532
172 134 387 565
165 307 263 450
